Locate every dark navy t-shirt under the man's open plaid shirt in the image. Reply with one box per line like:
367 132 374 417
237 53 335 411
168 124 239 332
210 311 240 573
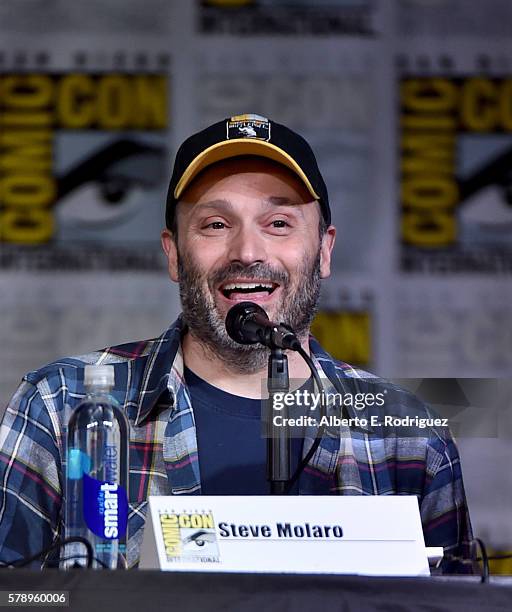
185 367 303 495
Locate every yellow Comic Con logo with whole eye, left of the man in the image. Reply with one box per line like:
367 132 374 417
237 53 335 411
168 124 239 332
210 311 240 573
0 57 168 269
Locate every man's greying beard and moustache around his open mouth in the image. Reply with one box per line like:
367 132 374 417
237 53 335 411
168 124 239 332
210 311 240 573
178 249 320 374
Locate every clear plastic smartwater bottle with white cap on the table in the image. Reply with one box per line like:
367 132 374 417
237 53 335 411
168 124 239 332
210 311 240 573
62 365 129 569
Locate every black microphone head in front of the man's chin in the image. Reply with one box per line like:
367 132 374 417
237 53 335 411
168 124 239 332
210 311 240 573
226 302 302 351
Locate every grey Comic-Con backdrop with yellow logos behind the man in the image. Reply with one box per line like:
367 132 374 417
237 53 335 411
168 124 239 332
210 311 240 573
0 0 512 568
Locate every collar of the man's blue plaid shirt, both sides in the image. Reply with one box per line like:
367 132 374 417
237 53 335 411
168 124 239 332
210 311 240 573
135 314 372 432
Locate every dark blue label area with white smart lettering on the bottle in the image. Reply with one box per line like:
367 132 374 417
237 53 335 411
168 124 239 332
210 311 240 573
83 474 128 540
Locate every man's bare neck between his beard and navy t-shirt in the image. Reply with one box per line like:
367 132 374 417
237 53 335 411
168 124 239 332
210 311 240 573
182 332 311 399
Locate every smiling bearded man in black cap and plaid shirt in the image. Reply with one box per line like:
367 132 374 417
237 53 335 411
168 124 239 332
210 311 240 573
0 115 471 571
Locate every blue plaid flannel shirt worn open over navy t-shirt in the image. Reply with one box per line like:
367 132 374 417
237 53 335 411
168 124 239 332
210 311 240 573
0 317 472 572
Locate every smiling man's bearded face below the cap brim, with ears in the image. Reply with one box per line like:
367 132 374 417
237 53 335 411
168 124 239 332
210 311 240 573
162 158 335 373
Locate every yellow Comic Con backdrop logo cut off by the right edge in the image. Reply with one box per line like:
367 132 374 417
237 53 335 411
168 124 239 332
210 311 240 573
399 62 512 273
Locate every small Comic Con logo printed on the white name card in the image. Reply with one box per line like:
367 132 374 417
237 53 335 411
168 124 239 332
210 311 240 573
159 510 220 563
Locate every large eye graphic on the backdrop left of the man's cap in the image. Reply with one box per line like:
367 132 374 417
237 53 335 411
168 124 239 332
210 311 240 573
55 138 165 229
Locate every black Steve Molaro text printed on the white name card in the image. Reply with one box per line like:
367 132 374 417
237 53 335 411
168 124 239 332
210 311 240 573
219 523 343 539
